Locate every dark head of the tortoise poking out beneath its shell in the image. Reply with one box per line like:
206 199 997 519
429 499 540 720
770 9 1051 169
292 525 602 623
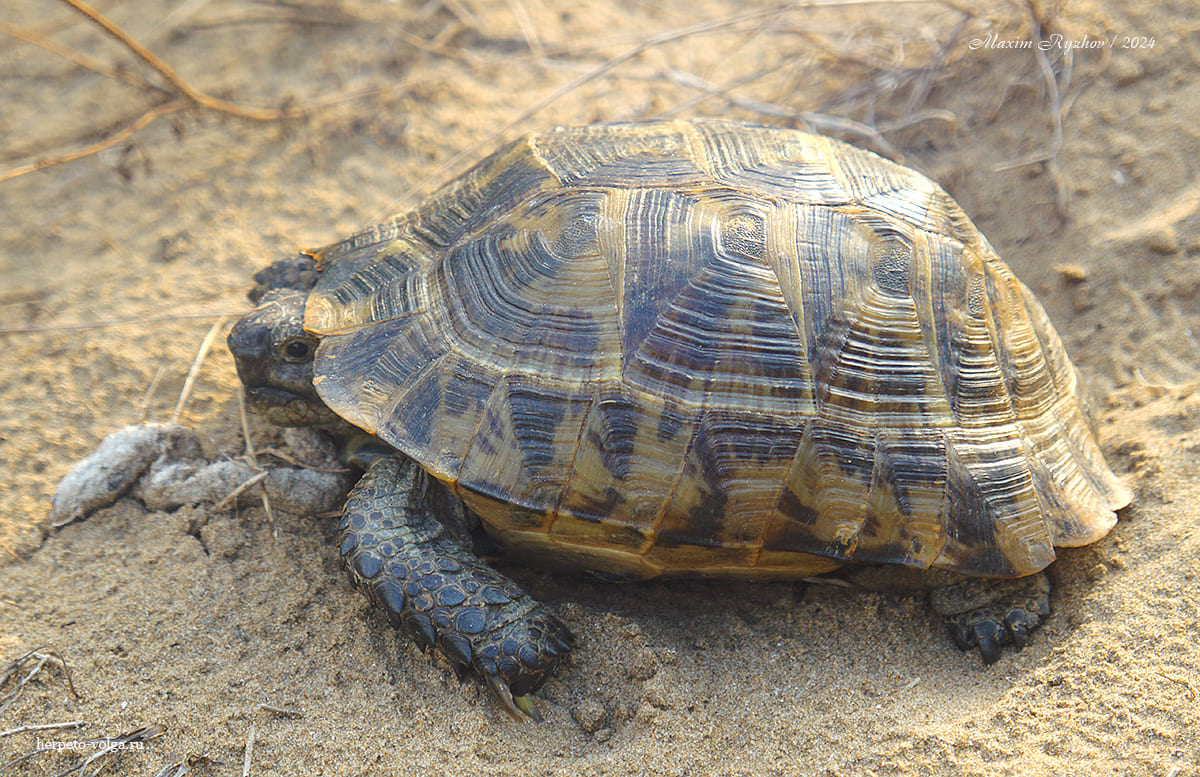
228 289 340 427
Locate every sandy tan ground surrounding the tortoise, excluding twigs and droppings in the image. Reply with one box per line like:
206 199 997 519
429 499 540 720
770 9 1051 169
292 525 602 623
0 0 1200 777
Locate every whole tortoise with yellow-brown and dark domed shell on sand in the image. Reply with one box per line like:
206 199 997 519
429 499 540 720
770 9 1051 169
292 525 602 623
229 120 1130 715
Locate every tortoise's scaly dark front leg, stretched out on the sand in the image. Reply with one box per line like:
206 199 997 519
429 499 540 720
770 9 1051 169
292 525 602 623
340 456 574 718
